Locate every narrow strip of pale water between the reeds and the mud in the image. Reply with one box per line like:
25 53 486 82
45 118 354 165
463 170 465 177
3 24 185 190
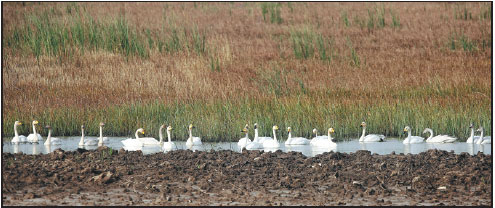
2 136 492 156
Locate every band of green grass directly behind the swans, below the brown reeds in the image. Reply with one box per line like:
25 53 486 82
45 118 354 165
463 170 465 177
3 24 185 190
3 96 491 142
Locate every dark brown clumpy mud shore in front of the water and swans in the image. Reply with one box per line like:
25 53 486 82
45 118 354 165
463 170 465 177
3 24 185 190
2 147 493 206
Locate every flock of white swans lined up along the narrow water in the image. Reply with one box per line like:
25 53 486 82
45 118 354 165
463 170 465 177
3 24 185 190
11 120 491 150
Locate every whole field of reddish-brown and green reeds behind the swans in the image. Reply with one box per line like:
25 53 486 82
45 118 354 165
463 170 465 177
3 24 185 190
2 2 492 141
